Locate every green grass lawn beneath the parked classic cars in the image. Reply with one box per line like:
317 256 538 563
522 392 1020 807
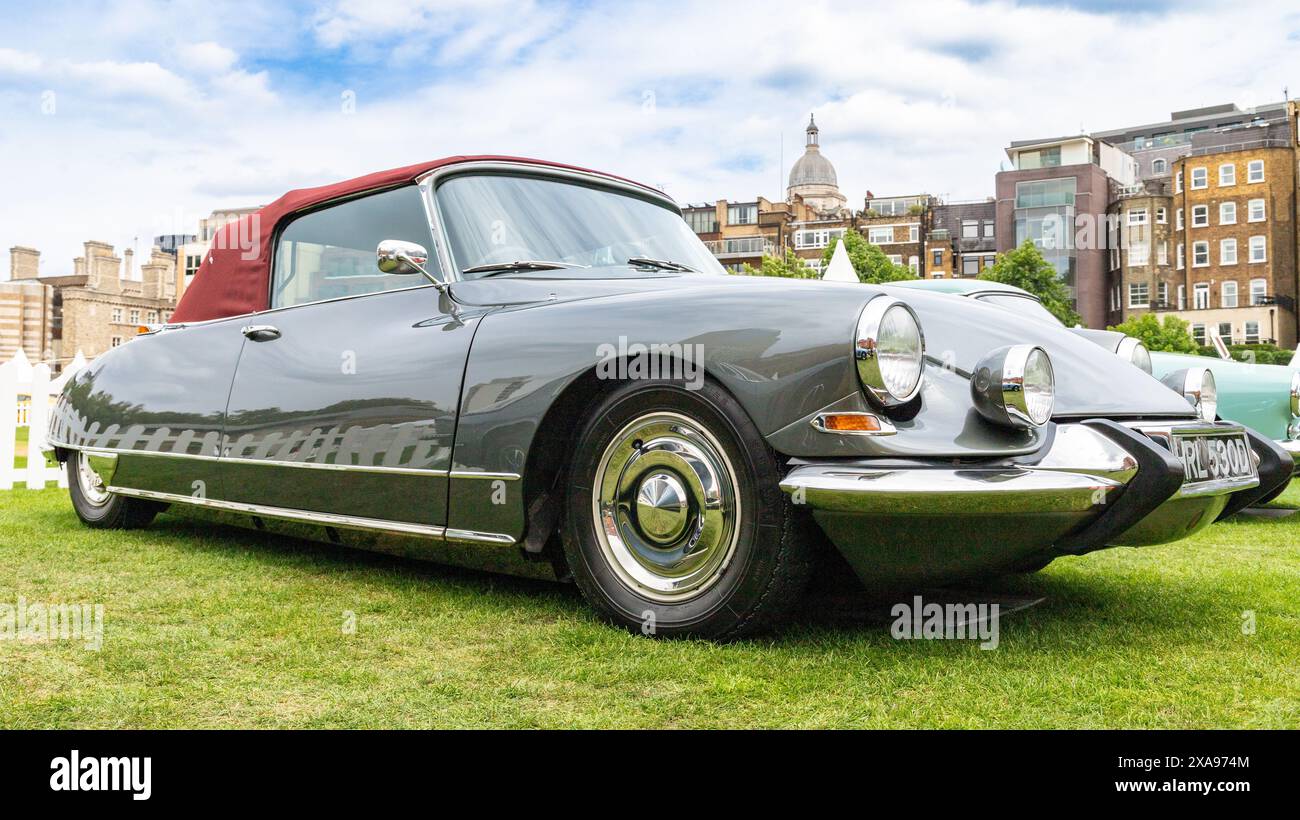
0 483 1300 728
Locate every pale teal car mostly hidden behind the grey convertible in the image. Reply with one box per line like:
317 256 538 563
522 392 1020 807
896 279 1300 491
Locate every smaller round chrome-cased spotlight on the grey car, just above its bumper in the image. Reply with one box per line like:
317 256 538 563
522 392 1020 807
971 344 1056 428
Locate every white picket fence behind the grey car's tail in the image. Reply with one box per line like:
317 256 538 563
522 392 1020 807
0 348 86 490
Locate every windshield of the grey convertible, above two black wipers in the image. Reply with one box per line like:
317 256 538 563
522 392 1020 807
437 174 725 279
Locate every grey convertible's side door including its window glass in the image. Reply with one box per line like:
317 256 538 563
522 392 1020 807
221 186 477 532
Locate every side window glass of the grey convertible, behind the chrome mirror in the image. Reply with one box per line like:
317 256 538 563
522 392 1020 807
270 186 436 308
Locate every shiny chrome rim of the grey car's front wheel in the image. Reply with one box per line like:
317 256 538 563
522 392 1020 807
592 413 741 602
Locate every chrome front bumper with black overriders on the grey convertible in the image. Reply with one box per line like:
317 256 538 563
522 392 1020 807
781 420 1260 583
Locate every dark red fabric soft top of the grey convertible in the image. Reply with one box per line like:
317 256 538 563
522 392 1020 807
172 156 653 322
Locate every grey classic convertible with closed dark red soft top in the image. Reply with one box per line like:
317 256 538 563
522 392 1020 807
38 157 1277 639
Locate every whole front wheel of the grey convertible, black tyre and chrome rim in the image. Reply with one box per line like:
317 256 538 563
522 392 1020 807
564 382 813 639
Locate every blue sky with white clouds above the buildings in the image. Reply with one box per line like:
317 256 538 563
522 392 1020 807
0 0 1300 278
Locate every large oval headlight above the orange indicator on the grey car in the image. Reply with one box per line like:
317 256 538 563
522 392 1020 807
853 296 926 408
